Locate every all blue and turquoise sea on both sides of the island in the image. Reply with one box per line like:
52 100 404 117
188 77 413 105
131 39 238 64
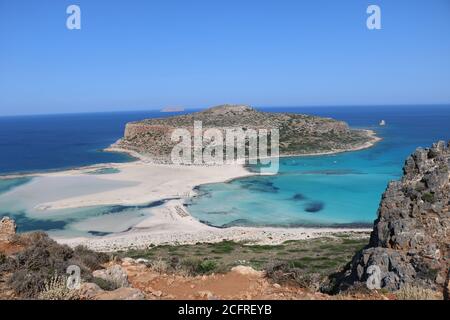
0 106 450 235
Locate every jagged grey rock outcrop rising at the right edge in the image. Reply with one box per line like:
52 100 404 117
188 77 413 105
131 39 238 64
339 141 450 290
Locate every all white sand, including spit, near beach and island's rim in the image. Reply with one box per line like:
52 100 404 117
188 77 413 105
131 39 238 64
0 130 381 251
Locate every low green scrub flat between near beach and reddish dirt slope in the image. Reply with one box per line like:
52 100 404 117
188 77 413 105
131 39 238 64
119 234 368 289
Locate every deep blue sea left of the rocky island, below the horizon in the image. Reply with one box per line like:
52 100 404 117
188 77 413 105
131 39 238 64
0 111 192 174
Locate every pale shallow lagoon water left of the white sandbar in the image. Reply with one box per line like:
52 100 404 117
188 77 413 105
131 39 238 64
0 173 164 236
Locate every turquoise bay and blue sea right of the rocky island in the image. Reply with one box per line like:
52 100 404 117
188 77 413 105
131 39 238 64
188 106 450 227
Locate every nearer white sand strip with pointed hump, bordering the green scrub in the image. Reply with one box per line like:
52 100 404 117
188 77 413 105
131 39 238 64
54 200 372 252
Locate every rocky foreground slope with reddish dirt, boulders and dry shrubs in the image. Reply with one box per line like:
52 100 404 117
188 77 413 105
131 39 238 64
0 220 442 300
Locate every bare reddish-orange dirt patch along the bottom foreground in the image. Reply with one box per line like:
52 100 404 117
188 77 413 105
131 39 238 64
122 263 392 300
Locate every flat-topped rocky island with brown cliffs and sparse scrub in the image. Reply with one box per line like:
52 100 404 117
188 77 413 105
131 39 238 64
110 105 379 162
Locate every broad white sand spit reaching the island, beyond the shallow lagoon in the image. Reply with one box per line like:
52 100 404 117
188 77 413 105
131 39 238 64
22 161 252 210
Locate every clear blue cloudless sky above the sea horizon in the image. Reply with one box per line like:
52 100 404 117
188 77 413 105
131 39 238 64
0 0 450 115
